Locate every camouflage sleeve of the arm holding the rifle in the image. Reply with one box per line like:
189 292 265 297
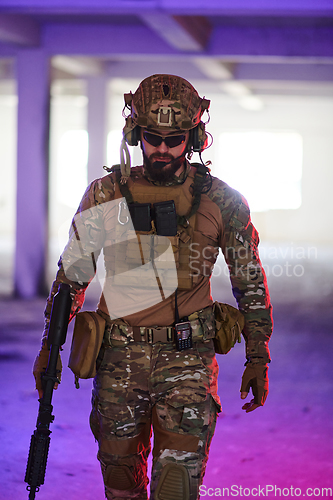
42 176 114 346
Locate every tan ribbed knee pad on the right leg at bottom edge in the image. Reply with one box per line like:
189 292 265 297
154 464 190 500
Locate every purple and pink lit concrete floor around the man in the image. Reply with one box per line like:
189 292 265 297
0 252 333 500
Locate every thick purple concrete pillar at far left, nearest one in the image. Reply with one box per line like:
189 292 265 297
14 48 50 298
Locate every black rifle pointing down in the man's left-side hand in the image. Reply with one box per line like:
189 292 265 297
24 283 72 500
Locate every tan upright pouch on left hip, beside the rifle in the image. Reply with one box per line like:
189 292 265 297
68 311 105 378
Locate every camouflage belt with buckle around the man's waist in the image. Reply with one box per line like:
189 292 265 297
103 316 203 346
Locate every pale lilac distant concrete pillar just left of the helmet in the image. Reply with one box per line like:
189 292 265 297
87 75 108 182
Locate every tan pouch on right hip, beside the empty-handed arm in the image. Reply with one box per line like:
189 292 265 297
213 302 245 354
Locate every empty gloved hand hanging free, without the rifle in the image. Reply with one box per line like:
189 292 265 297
240 363 268 413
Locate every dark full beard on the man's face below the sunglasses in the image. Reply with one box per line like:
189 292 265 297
143 153 185 183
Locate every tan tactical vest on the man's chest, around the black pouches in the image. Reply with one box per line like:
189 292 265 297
104 167 218 290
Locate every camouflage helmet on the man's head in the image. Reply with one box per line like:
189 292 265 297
123 75 210 146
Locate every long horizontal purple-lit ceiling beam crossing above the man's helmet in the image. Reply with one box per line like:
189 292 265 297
39 24 333 61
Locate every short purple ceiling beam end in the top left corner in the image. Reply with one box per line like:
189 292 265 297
0 14 40 46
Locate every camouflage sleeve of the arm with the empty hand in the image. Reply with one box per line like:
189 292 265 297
211 181 273 363
